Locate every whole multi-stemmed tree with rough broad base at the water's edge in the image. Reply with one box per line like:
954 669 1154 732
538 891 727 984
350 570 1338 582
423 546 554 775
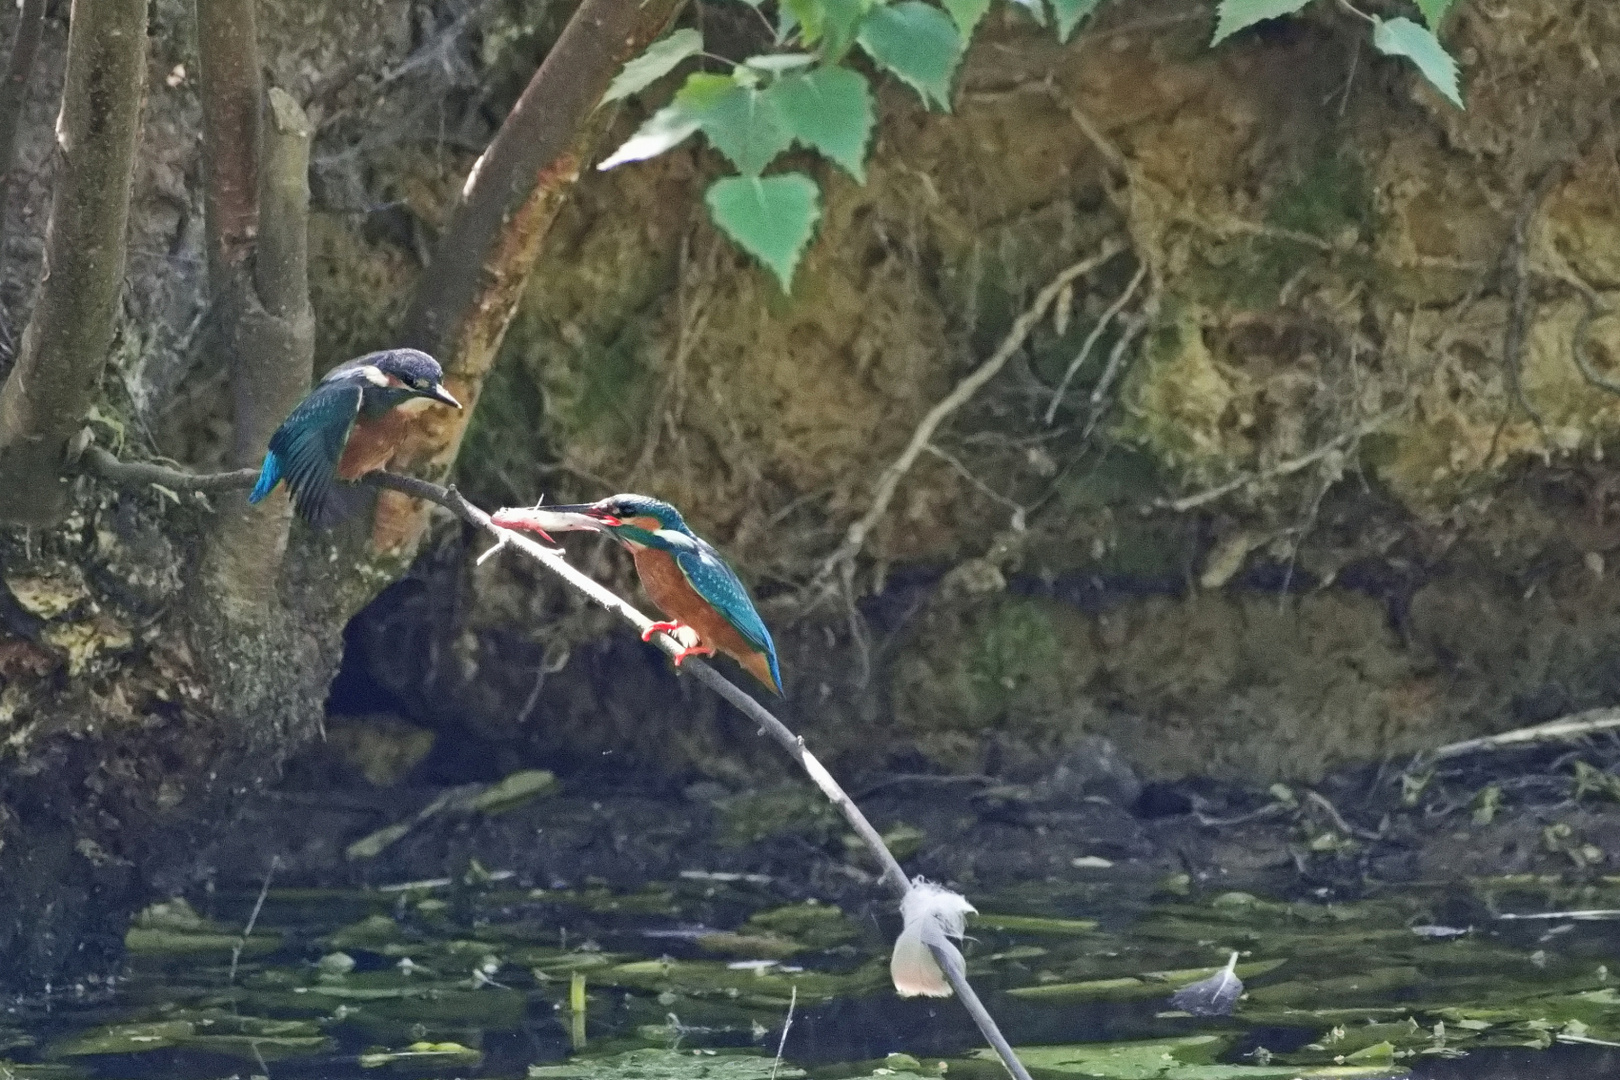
0 0 690 988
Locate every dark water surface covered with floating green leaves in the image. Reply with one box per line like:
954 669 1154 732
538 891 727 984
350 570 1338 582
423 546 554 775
0 876 1620 1080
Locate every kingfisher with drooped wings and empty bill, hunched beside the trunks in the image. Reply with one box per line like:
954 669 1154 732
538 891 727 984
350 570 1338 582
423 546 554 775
248 348 462 526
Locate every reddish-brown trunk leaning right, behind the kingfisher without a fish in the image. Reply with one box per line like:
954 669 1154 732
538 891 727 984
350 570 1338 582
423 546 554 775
373 0 682 551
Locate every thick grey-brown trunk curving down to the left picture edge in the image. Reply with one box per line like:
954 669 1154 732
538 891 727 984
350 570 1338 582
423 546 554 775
0 0 147 526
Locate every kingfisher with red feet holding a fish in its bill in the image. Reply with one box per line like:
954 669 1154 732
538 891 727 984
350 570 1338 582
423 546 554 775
491 495 782 695
